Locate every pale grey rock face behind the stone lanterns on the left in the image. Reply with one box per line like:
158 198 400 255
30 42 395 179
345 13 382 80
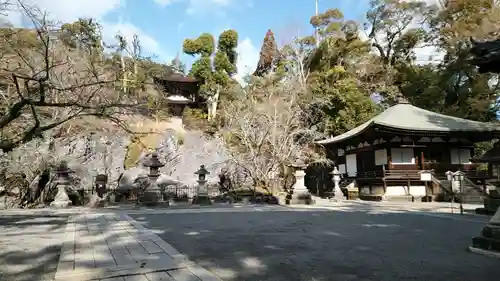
0 123 228 207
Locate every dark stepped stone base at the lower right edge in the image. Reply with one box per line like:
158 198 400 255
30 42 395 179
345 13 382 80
469 206 500 254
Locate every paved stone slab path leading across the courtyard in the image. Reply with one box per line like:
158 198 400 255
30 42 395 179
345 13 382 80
55 213 220 281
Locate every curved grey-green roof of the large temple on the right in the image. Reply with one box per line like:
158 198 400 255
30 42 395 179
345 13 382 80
316 100 500 144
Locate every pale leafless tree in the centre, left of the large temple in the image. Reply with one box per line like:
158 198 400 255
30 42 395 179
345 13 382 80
222 76 324 195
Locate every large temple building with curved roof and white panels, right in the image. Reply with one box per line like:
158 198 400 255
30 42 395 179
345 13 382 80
317 99 500 200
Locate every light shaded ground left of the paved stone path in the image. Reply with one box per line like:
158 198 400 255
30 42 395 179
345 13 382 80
0 214 67 281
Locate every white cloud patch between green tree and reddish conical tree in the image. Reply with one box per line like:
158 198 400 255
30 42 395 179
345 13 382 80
234 37 260 84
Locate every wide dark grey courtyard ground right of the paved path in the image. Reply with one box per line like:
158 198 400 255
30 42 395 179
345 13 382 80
131 206 500 281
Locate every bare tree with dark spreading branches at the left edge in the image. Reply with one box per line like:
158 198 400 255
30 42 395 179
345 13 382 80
0 1 143 152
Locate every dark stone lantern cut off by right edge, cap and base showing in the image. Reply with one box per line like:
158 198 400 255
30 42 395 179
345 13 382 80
469 39 500 257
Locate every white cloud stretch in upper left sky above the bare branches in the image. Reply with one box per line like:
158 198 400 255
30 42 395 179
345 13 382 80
7 0 168 59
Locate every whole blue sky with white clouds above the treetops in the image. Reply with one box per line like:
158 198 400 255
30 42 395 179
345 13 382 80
4 0 369 79
